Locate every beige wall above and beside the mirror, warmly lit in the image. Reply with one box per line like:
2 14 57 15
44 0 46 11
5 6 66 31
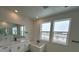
0 7 33 40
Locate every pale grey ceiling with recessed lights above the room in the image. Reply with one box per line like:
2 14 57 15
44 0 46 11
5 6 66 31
0 6 79 19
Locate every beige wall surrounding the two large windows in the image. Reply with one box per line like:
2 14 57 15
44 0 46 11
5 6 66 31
34 10 79 52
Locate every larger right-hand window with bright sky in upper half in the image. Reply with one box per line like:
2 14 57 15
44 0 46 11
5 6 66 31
53 20 70 45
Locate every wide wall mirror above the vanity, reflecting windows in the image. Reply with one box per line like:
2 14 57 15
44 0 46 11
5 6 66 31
0 21 26 38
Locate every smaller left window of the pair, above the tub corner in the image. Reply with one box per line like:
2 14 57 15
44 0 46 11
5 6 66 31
40 22 50 41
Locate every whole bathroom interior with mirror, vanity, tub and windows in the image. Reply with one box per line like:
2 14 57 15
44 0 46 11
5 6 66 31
0 6 79 52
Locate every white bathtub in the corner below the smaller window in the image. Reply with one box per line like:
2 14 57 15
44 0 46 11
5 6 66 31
30 42 46 52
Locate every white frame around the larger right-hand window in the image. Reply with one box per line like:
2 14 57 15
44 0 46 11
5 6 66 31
51 18 71 46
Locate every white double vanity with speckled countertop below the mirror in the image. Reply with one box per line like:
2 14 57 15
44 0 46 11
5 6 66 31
0 40 29 52
